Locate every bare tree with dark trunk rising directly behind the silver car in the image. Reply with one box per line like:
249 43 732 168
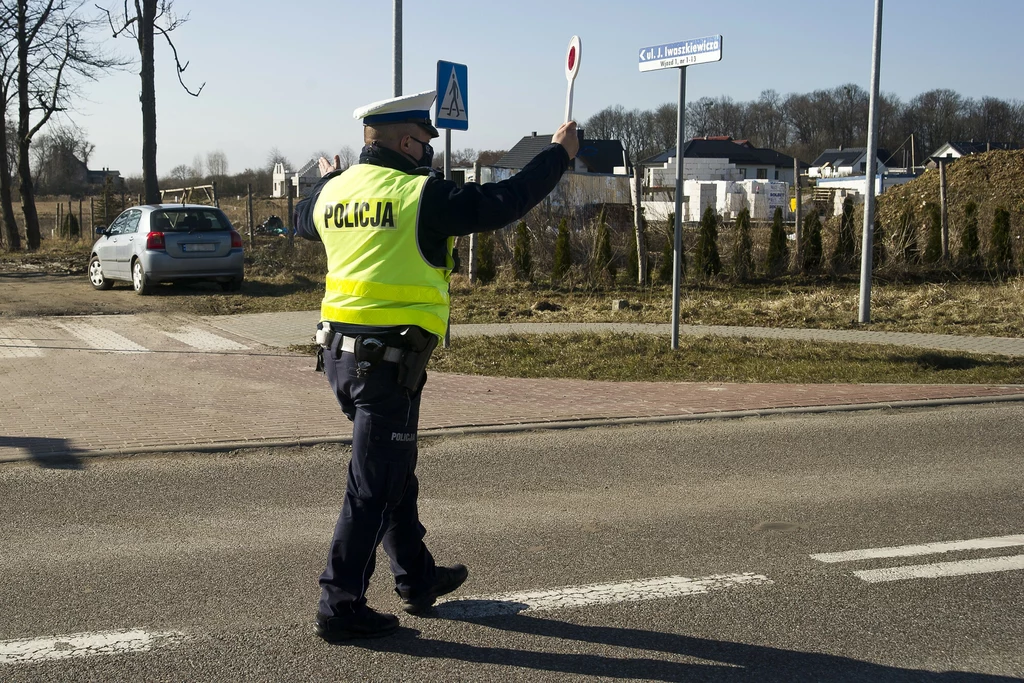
100 0 206 204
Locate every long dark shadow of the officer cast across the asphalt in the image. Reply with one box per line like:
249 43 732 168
350 614 1022 683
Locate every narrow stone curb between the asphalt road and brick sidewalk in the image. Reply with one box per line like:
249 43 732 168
0 393 1024 466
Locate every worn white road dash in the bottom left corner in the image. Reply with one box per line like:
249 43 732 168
0 629 184 665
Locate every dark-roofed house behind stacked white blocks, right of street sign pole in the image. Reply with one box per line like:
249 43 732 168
643 135 807 187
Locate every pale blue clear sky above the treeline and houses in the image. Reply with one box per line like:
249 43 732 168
69 0 1024 176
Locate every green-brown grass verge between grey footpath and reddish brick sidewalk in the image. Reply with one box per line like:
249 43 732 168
294 334 1024 384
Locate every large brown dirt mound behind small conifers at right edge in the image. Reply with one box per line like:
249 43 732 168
878 150 1024 242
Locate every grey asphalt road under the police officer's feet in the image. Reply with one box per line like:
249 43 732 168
0 404 1024 682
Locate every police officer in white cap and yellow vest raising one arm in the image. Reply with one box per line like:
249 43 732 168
295 91 579 642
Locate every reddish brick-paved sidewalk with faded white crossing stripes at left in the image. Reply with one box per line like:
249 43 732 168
0 312 1024 467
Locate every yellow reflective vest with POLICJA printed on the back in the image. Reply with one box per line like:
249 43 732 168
313 164 454 337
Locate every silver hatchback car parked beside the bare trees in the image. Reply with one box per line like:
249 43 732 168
89 204 244 294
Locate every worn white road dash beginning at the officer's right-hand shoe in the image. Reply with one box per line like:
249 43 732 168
437 572 773 618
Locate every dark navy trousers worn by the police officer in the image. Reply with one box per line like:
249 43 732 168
319 350 434 615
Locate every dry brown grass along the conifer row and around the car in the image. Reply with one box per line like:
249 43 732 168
6 237 1024 337
